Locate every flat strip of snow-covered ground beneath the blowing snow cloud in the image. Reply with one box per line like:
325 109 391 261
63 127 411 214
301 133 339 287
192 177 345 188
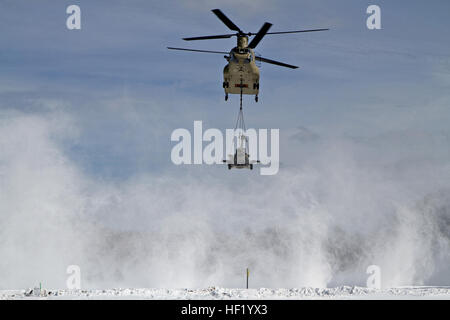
0 286 450 300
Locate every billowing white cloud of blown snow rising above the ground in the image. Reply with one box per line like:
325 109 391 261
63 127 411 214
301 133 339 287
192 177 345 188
0 107 450 288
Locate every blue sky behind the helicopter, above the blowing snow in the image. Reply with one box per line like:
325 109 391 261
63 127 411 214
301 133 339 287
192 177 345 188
0 1 450 176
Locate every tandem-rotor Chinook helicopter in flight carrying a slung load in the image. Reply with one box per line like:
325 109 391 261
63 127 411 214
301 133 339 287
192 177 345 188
168 9 329 102
